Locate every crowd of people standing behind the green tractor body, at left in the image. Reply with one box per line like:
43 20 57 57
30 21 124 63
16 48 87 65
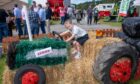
0 1 52 42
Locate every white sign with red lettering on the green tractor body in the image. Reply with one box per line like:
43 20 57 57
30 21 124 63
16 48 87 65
35 47 52 57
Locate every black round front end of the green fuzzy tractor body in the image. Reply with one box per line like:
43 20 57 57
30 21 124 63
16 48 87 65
6 42 19 69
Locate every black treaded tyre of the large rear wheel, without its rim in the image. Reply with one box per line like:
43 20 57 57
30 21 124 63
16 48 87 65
93 42 138 84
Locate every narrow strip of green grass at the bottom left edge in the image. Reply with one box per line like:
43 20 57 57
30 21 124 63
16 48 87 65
0 56 6 84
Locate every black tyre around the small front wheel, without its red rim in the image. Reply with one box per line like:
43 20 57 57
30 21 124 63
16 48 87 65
14 64 46 84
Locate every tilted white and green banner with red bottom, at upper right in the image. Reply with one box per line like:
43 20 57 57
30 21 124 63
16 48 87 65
119 0 131 16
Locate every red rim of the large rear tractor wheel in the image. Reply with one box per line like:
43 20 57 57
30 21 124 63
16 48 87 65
110 58 132 83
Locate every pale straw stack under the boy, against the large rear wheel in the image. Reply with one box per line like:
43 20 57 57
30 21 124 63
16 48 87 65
64 38 121 84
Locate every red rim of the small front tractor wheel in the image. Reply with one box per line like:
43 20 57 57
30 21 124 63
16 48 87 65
22 71 39 84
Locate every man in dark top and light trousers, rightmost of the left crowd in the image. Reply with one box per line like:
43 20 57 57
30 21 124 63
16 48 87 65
46 3 52 33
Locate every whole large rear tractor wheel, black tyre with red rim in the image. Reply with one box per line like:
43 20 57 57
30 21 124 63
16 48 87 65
93 42 138 84
